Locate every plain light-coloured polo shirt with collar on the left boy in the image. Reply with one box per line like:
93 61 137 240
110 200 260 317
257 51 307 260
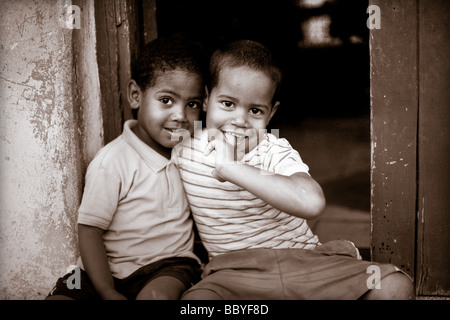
78 120 198 279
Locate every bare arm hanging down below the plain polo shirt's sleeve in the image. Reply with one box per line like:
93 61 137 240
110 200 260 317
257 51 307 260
78 224 126 300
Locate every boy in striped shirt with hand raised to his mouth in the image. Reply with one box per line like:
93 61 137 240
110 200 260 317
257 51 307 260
172 40 413 300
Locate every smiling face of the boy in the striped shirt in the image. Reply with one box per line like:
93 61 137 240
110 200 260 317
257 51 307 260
203 67 279 153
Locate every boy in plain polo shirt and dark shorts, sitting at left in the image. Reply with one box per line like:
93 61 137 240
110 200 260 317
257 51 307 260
48 37 204 299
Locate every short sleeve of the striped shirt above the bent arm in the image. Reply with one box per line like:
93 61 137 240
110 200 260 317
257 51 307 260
263 138 309 176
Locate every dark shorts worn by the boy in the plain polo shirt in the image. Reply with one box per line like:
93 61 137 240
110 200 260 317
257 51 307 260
48 257 201 300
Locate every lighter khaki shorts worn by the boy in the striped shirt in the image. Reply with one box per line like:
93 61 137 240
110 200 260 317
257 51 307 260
183 240 398 300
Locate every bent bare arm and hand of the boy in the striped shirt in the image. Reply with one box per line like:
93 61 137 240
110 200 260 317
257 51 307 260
205 140 325 219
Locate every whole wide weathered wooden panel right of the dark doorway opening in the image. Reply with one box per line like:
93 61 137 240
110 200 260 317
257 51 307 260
370 0 450 296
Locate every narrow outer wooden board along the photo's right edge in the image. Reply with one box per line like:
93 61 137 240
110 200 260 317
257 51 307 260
416 0 450 295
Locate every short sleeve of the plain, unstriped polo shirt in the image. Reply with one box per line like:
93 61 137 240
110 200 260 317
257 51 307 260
78 163 121 230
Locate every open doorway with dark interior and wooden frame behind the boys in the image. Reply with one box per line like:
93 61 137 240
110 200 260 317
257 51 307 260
92 0 450 296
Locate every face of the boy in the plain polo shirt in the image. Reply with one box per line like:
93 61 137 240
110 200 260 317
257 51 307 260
130 70 204 158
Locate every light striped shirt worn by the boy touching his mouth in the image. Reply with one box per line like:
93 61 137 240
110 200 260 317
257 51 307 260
172 129 320 258
